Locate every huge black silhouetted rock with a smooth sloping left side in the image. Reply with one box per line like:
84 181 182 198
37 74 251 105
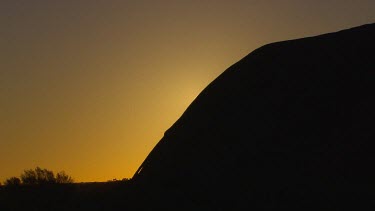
133 24 375 210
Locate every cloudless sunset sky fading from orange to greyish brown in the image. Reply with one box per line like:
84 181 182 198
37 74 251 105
0 0 375 182
